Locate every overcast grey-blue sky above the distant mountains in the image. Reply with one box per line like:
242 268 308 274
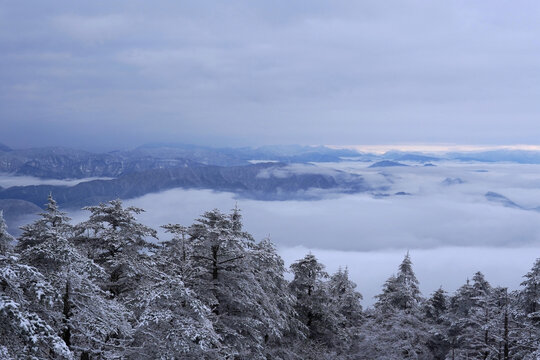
0 0 540 148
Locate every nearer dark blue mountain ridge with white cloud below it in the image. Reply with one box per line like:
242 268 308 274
0 163 368 207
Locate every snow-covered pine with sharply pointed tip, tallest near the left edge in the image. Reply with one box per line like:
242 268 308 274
18 196 130 356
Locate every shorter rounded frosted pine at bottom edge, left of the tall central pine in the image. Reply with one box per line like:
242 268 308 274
129 246 220 359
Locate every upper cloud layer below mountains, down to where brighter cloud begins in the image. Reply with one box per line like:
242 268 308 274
58 162 540 251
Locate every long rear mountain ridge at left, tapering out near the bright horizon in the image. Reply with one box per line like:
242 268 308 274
0 144 358 179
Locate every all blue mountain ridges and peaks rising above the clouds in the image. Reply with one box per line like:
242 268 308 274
5 144 540 229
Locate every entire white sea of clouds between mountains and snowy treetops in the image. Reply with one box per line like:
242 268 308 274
8 161 540 305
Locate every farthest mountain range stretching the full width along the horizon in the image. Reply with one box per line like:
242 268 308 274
5 144 540 179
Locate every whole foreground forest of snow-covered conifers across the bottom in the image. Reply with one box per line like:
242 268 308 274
0 196 540 359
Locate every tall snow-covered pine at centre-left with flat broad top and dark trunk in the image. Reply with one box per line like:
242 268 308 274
186 208 292 359
